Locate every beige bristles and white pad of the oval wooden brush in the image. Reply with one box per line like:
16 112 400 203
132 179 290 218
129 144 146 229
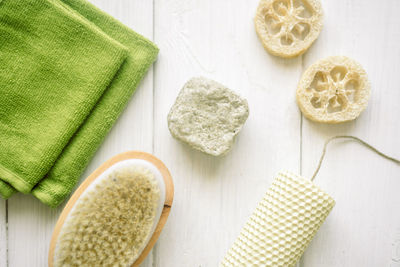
54 165 160 266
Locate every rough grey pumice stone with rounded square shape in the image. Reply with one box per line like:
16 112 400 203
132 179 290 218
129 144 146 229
168 77 249 156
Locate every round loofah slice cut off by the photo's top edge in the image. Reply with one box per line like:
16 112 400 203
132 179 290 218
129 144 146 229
254 0 323 58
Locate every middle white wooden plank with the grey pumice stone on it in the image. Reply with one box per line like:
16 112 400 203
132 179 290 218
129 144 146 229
154 0 301 267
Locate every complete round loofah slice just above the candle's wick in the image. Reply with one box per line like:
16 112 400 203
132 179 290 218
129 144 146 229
296 56 370 123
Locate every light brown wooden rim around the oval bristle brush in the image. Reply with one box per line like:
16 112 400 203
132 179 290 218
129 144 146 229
48 151 174 267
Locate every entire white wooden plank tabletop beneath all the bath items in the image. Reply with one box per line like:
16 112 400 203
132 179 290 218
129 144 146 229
0 0 400 267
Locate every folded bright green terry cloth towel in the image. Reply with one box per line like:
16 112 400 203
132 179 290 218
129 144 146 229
0 0 158 207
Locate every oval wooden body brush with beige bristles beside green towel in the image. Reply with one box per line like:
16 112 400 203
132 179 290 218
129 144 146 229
49 151 174 267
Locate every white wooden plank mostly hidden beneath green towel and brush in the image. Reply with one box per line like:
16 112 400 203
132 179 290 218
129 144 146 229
7 0 153 267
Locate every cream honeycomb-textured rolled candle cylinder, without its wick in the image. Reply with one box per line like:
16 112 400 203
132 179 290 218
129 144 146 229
220 172 335 267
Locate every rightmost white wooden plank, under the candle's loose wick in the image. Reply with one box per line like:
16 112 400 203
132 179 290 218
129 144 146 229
302 0 400 267
